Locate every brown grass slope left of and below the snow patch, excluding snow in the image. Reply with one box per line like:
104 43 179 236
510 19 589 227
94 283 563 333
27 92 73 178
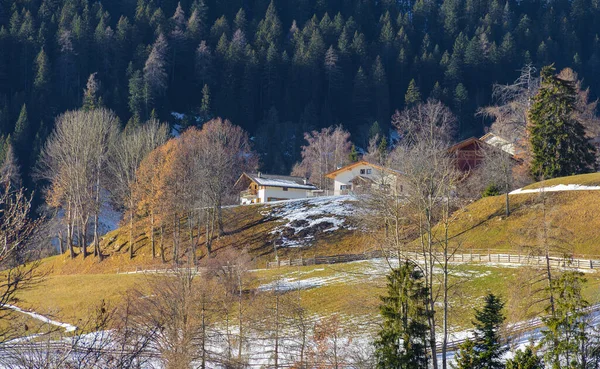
42 198 365 275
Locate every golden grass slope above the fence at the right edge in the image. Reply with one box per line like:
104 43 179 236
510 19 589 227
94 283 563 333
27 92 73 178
450 191 600 257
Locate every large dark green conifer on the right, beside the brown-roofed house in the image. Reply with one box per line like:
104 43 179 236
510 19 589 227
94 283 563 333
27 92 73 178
529 66 596 179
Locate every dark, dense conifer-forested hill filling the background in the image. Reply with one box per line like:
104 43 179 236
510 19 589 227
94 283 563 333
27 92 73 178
0 0 600 172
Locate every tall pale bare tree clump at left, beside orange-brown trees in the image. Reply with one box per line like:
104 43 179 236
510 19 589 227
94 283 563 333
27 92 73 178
37 109 119 257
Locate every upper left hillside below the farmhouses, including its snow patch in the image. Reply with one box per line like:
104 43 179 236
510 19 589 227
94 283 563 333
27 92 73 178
38 196 372 274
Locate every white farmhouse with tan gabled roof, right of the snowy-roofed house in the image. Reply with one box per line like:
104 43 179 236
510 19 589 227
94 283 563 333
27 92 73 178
326 160 405 196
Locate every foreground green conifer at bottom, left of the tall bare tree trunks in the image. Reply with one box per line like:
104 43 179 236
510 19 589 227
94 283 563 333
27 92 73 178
375 261 429 369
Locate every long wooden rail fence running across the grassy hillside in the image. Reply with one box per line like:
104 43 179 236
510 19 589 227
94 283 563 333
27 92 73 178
267 250 600 270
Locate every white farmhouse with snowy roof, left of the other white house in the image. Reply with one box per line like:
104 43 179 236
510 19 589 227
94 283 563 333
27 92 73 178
234 173 317 205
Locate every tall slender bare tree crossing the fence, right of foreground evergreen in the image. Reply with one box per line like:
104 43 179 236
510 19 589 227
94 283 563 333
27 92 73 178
391 101 460 369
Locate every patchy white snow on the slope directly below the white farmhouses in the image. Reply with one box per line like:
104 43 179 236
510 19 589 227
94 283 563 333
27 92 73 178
263 196 355 247
